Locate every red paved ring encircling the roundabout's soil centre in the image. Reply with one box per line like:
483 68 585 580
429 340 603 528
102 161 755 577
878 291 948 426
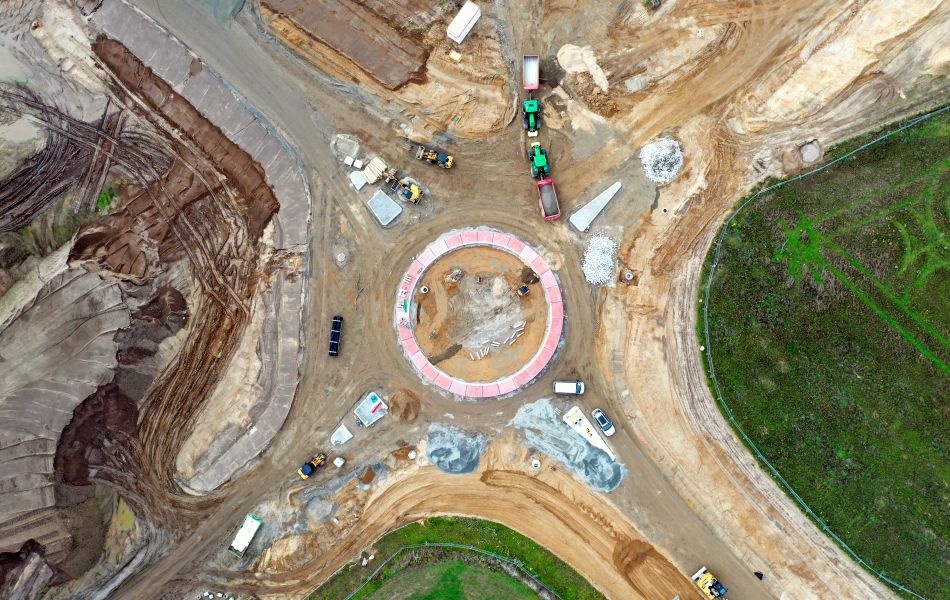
393 228 564 398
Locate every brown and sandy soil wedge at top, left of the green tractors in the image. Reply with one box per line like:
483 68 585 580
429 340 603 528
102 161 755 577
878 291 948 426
260 0 515 138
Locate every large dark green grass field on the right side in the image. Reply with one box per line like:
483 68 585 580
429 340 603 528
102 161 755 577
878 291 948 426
701 113 950 598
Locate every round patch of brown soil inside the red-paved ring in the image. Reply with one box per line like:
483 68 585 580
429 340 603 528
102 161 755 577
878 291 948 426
413 246 548 382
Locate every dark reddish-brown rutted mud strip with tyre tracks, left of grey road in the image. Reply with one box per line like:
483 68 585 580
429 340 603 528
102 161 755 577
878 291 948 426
59 37 278 536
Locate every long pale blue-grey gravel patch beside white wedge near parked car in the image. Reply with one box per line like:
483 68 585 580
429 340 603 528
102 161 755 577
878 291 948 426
511 398 627 492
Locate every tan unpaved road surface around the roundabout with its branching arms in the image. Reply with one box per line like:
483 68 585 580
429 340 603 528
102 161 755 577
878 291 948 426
39 0 950 599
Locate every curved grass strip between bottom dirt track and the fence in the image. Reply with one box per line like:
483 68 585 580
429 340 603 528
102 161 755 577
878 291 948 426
309 517 604 600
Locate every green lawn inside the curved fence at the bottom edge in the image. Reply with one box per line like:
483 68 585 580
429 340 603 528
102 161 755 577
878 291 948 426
354 560 538 600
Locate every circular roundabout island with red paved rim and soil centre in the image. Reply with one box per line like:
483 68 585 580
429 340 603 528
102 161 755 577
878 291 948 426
394 228 564 399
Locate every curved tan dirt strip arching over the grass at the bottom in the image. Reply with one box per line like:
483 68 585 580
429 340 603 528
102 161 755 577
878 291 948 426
210 441 701 600
